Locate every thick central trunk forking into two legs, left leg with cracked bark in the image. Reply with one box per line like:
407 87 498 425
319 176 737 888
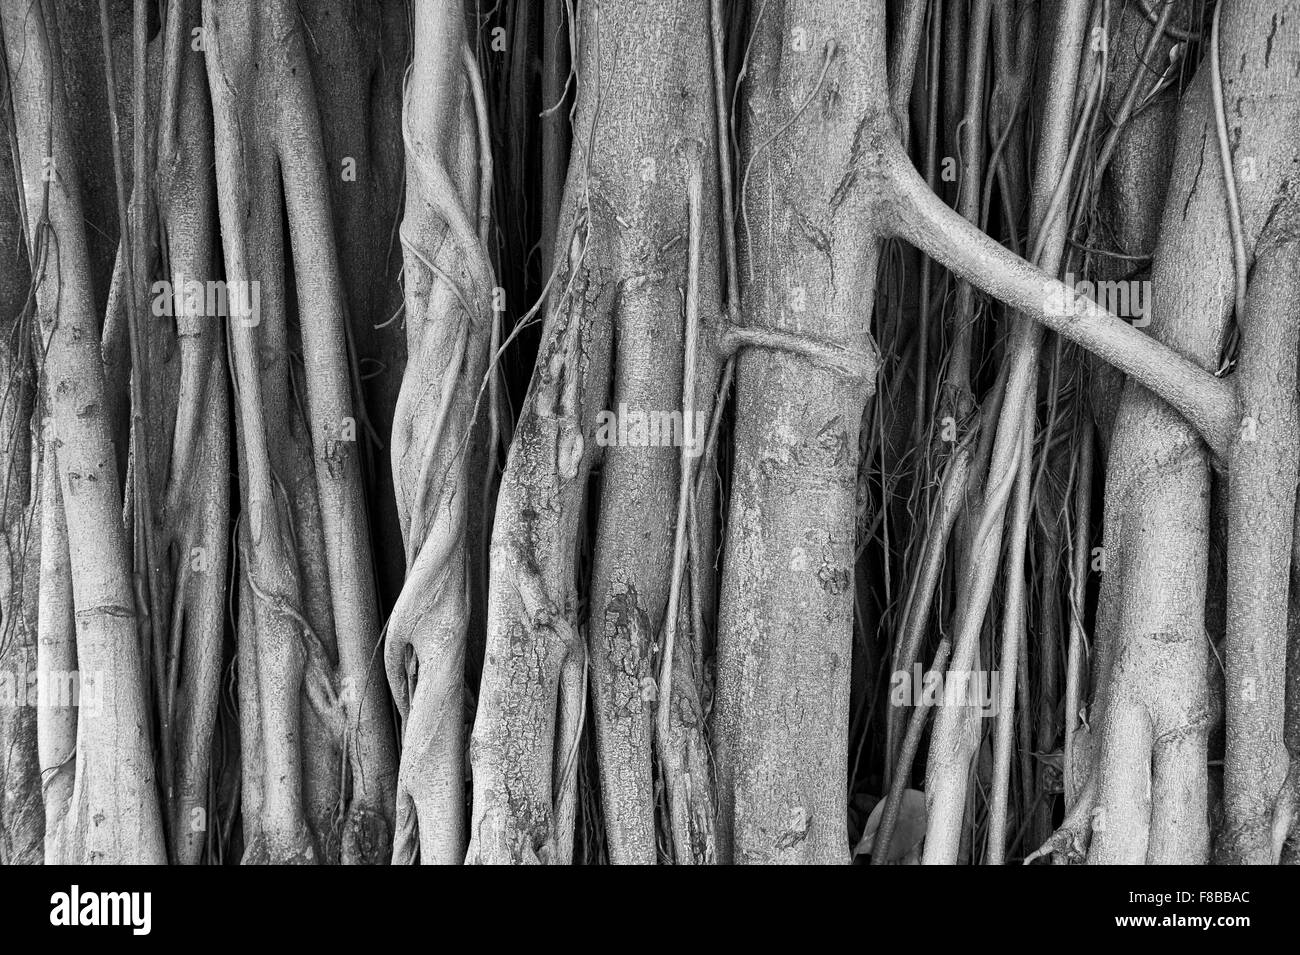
469 3 718 863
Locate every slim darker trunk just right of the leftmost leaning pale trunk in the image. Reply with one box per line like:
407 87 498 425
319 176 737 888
153 0 230 864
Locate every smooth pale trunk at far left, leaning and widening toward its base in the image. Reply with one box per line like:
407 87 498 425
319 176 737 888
0 0 164 863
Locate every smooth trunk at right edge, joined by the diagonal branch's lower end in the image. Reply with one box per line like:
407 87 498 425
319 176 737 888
1217 235 1300 865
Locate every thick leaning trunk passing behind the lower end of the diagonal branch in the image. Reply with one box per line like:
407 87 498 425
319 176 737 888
1088 3 1296 863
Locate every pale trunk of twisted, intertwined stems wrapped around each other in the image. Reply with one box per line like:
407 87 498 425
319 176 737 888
385 4 498 864
